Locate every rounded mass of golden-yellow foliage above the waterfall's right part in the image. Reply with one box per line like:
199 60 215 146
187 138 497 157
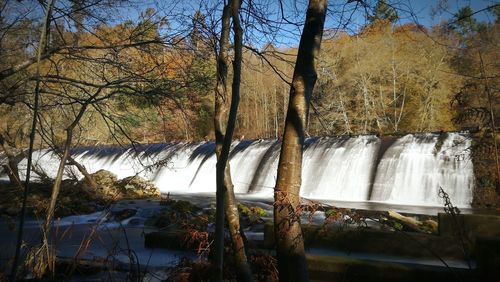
312 22 461 132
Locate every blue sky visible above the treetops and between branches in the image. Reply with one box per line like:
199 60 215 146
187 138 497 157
2 0 500 46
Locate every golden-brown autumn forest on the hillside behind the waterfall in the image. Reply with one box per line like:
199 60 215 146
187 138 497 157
0 2 499 147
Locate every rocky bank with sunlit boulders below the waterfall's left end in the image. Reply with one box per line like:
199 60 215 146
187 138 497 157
0 170 160 220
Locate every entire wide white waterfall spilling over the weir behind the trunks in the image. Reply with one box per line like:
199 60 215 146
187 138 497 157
1 133 474 207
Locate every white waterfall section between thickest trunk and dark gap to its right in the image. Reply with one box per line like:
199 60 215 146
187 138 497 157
301 136 380 201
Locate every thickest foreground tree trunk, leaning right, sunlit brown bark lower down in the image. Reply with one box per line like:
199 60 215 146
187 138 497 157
274 0 327 281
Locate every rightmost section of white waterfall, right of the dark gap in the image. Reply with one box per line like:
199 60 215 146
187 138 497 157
370 133 474 206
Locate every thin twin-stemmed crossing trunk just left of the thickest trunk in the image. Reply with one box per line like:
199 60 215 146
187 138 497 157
214 0 252 281
